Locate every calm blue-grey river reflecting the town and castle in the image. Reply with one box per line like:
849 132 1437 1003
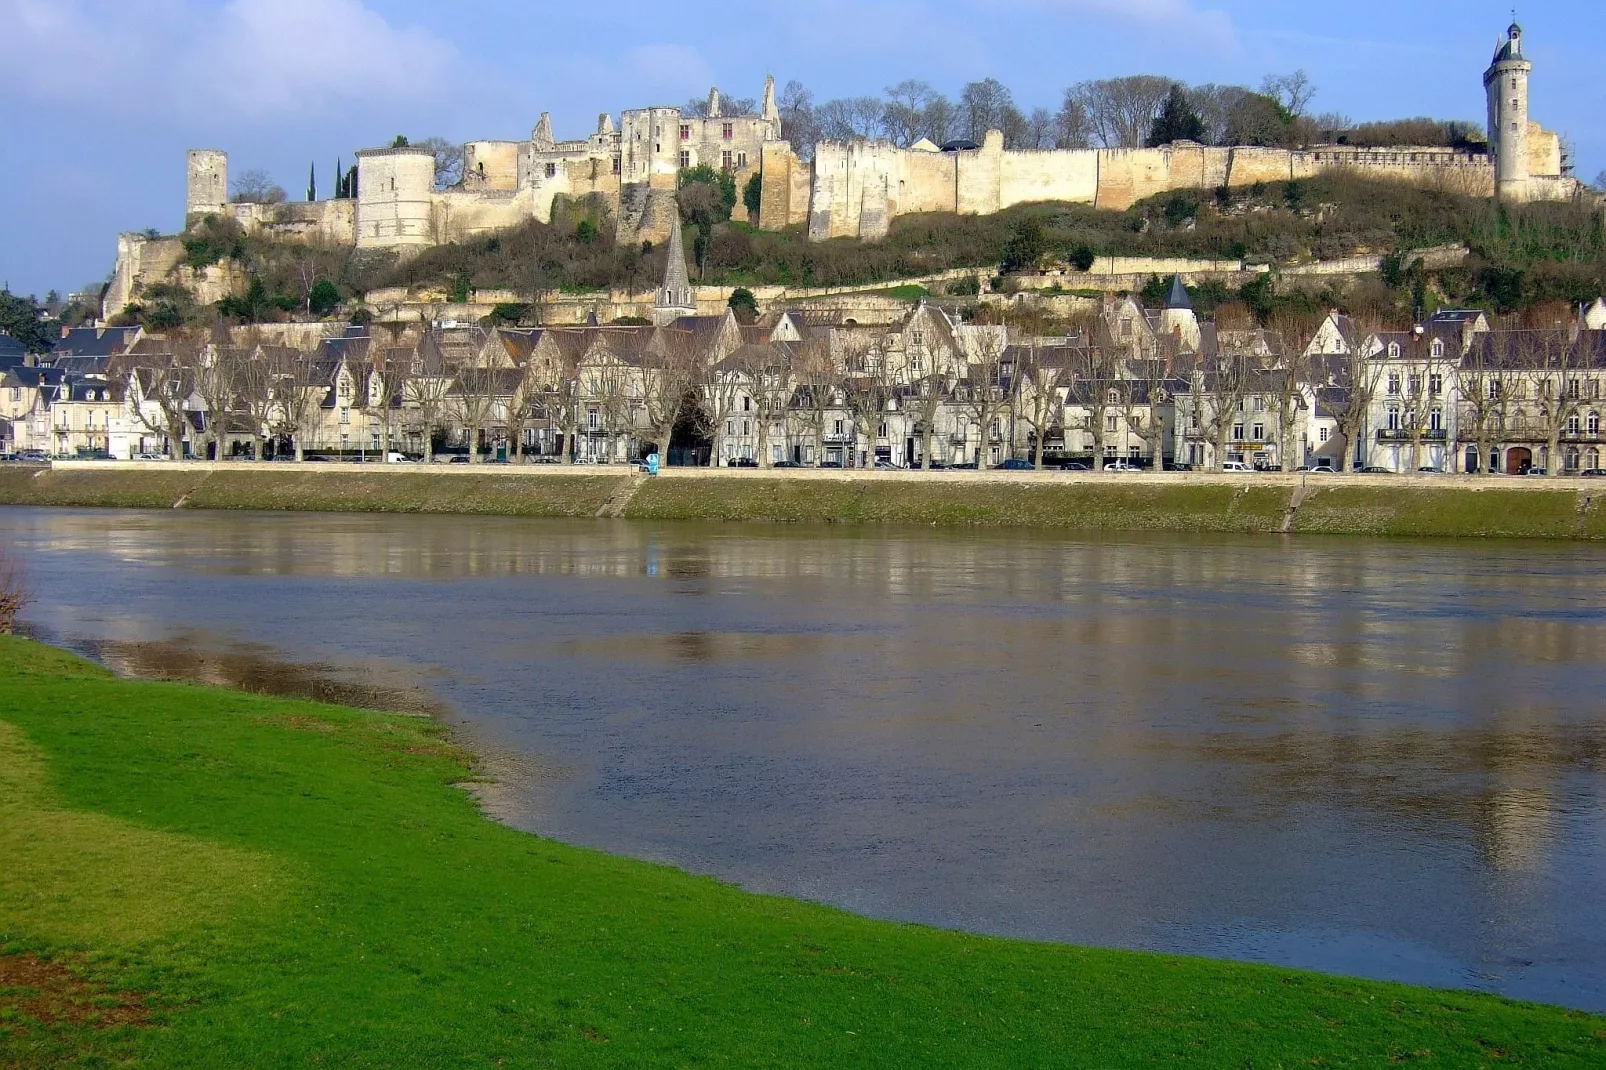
0 509 1606 1011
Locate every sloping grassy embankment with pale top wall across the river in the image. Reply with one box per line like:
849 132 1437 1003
9 461 1606 540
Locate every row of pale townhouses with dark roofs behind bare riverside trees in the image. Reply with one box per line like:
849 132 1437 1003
12 281 1606 472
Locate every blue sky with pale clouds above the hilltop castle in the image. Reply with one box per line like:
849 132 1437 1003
0 0 1606 296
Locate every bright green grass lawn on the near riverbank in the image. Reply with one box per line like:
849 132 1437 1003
0 639 1606 1067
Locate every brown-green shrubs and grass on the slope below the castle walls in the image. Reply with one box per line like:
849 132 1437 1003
116 174 1606 334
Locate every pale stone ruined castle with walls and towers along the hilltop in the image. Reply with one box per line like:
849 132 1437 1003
106 24 1579 313
